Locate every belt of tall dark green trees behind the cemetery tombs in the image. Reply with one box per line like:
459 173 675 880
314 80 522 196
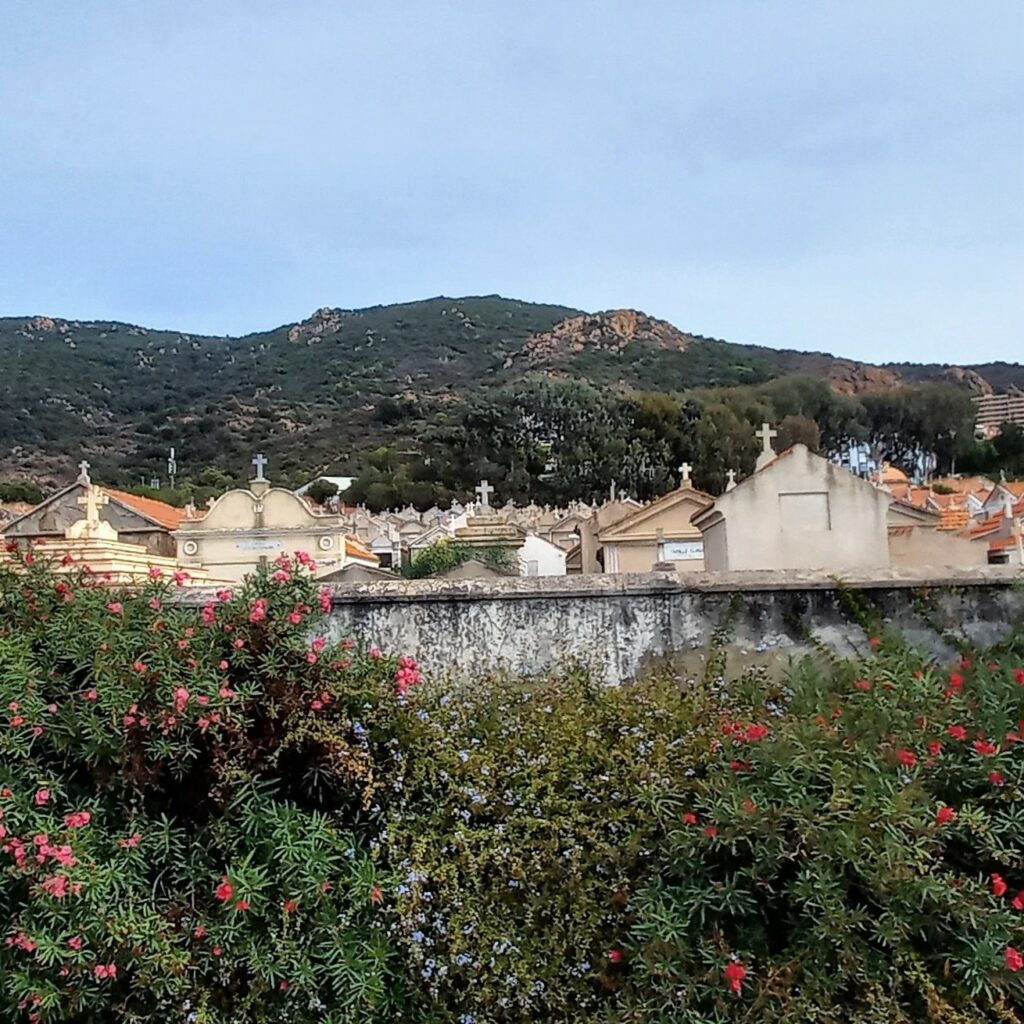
345 376 991 509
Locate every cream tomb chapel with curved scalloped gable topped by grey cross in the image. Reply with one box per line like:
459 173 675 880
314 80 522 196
174 455 380 581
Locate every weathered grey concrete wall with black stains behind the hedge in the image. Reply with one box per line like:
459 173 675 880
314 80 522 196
234 566 1024 683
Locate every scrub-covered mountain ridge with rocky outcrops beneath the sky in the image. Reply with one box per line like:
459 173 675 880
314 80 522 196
0 295 1024 482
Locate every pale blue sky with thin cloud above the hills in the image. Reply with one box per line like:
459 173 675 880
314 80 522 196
0 0 1024 362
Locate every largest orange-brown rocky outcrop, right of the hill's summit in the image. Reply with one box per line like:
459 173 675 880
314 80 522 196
523 309 695 367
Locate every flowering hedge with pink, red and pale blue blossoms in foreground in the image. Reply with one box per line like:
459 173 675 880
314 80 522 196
0 551 1024 1024
